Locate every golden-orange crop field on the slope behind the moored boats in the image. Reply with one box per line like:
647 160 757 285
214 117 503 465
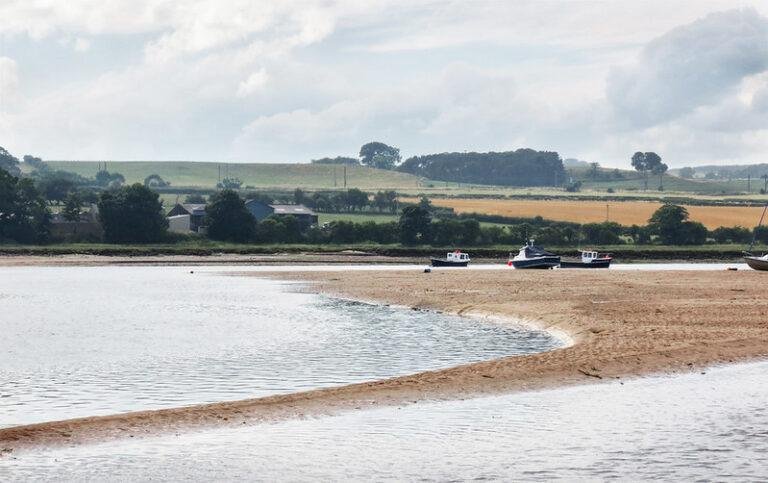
414 198 763 229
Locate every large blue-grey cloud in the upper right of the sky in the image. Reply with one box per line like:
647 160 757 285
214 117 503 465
606 9 768 127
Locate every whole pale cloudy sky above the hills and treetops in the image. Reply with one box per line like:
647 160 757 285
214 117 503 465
0 0 768 167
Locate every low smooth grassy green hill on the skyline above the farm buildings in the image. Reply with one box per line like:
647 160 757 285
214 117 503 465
47 161 421 190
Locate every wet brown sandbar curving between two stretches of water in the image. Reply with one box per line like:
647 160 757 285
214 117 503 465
0 269 768 450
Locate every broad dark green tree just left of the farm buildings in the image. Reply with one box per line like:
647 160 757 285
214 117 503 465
98 183 168 243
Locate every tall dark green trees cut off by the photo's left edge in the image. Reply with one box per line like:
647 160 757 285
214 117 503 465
0 169 51 243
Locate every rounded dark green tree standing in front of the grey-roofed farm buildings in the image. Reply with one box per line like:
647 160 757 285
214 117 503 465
205 190 256 243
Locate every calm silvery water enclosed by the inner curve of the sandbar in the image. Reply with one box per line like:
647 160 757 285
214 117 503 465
0 267 562 426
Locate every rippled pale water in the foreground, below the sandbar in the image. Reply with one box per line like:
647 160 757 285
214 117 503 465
6 363 768 481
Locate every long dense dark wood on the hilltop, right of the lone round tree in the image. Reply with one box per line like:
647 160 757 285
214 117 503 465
397 149 565 186
